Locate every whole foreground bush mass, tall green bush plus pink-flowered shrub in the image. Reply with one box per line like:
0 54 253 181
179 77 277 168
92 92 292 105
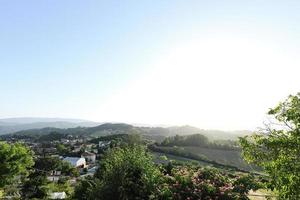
74 146 259 200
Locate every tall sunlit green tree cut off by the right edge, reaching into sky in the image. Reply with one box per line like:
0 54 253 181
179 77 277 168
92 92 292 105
240 93 300 199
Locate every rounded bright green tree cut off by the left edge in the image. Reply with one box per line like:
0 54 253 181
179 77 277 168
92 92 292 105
0 142 34 188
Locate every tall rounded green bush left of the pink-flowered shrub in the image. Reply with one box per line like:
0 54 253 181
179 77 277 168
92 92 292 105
94 146 161 200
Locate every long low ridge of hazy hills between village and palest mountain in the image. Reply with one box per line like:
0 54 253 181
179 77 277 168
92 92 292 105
1 123 251 140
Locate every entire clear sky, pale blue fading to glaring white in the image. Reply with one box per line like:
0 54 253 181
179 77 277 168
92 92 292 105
0 0 300 130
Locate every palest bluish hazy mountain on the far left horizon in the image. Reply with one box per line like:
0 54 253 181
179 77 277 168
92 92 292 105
0 118 101 135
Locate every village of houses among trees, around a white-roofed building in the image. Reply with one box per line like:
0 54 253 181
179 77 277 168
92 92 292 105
2 133 111 199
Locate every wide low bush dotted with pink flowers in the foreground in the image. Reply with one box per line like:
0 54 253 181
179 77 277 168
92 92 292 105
158 166 259 200
